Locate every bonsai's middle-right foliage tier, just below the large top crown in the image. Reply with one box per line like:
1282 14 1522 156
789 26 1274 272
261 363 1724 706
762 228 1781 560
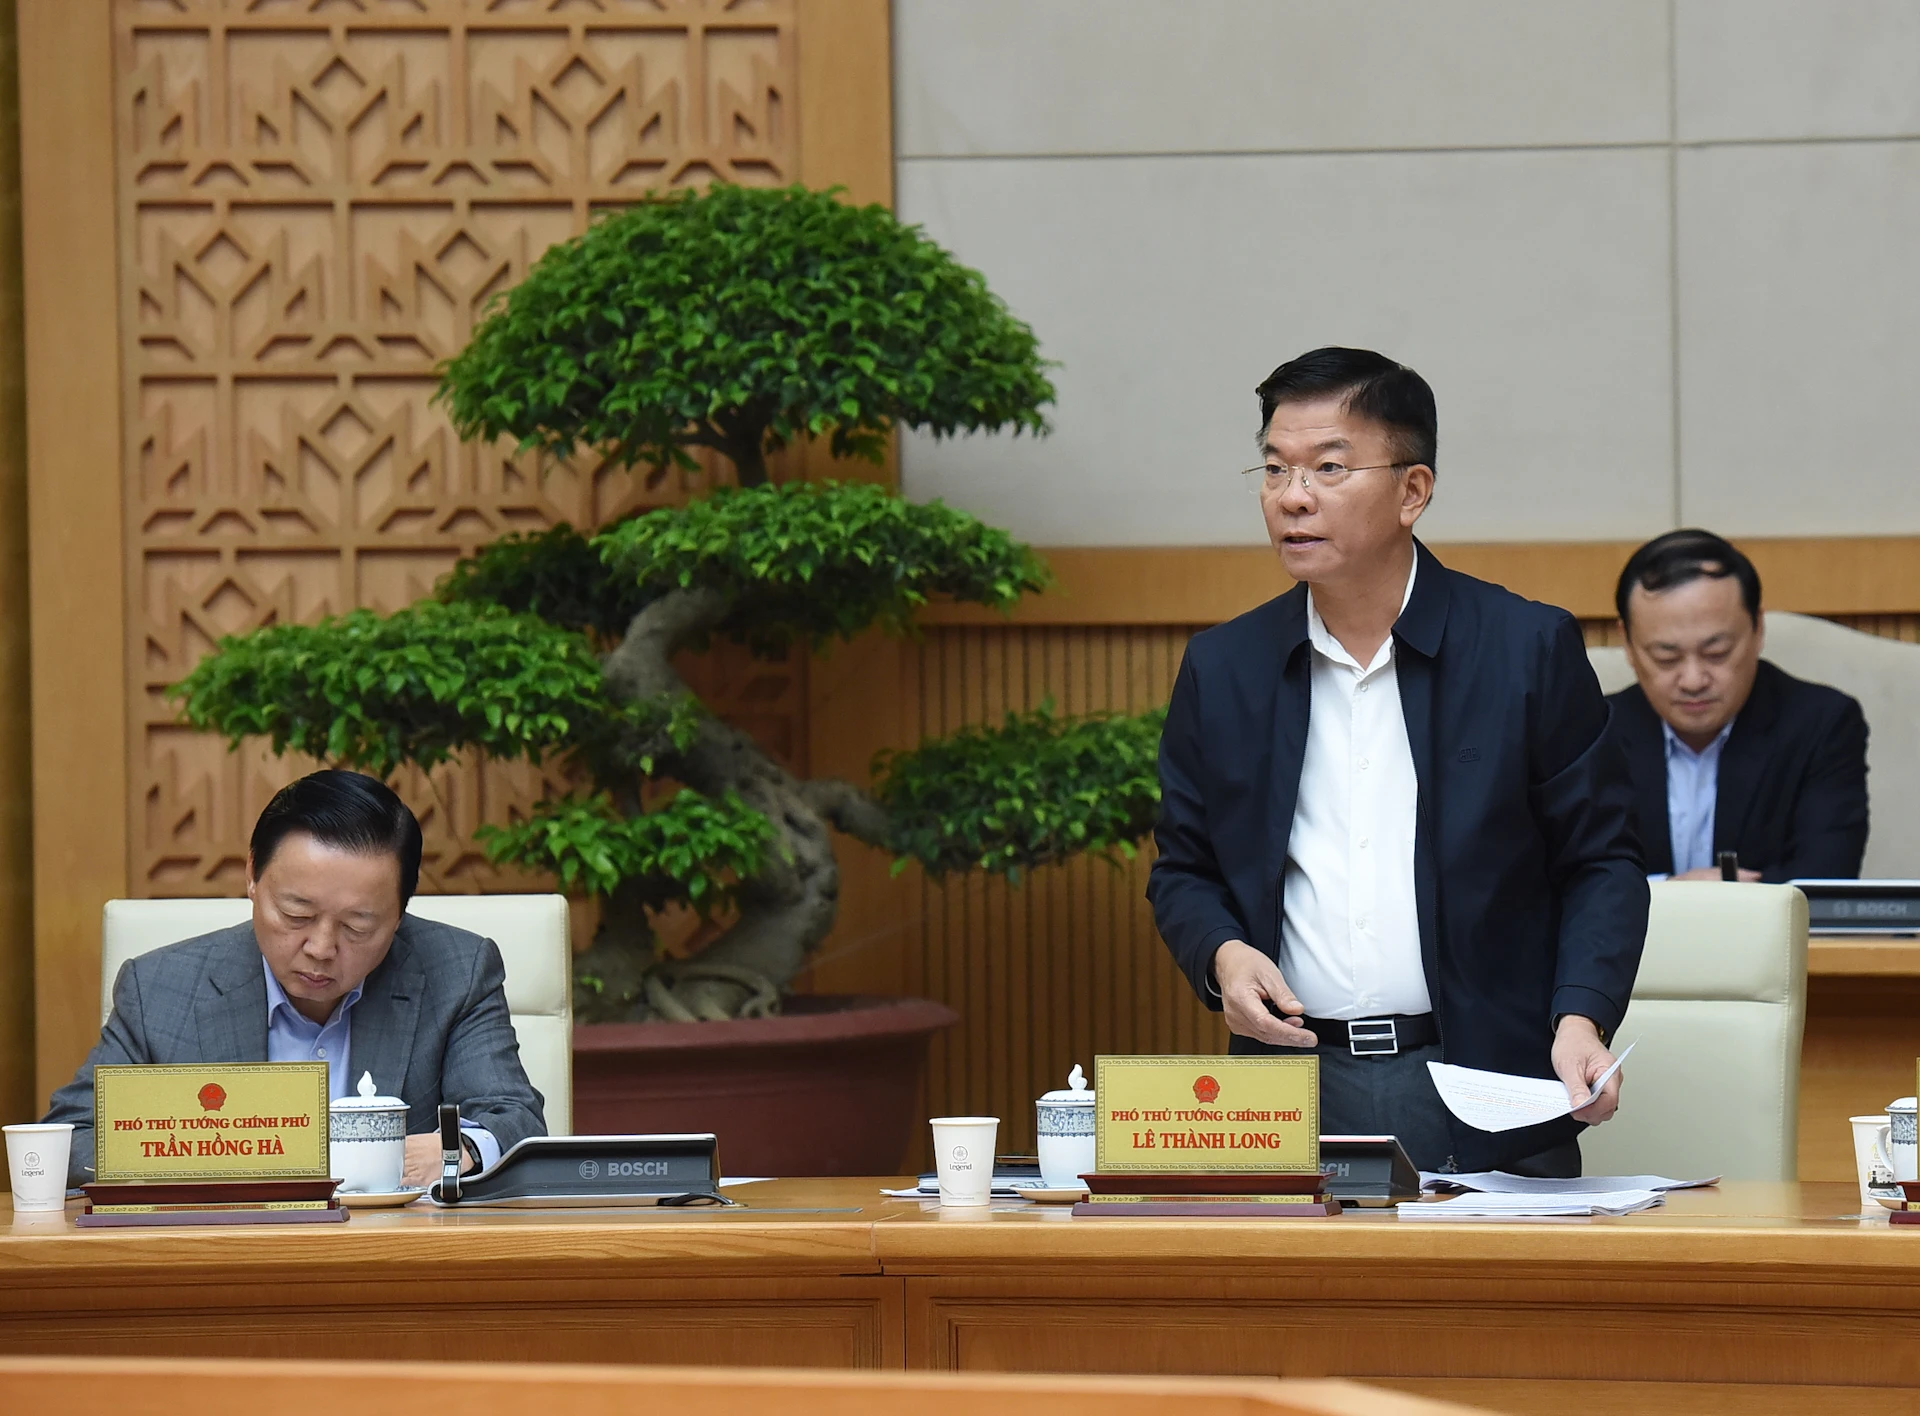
595 482 1046 649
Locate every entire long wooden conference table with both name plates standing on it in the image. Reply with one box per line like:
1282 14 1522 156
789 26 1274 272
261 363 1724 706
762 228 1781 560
0 1180 1920 1416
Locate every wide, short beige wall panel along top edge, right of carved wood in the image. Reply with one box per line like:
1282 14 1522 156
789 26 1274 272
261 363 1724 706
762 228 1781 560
895 0 1666 157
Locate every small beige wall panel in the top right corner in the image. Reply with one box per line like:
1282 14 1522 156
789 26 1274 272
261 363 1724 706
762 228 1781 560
1674 0 1920 142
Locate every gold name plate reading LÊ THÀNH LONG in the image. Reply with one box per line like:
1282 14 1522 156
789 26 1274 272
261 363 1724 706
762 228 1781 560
1092 1057 1321 1174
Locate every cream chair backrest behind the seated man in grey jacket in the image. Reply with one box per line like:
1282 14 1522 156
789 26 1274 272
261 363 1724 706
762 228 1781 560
100 894 574 1136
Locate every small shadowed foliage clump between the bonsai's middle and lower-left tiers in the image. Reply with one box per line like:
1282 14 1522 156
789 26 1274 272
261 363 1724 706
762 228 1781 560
438 522 655 639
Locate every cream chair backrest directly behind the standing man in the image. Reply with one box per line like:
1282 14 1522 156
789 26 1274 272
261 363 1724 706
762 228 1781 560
1580 881 1807 1180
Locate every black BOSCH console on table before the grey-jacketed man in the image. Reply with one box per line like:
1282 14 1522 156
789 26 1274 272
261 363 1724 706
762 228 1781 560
428 1132 733 1209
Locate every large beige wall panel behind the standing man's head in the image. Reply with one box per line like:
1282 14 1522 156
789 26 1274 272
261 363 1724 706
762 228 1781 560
899 150 1672 545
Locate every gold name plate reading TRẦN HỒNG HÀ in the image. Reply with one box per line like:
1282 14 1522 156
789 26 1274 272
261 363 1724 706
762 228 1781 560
94 1063 328 1182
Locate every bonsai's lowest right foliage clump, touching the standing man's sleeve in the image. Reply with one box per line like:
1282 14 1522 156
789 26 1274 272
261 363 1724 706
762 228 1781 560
874 702 1165 879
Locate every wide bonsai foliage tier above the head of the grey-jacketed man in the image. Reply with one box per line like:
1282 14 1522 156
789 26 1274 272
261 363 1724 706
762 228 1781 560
167 601 618 777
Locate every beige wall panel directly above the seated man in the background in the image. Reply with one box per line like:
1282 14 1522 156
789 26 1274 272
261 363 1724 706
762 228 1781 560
1680 142 1920 535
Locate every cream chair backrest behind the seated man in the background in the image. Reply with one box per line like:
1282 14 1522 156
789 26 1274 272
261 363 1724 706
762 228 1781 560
1586 610 1920 881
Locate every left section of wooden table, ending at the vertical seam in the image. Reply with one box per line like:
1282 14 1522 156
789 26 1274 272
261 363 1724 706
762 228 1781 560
0 1180 904 1368
